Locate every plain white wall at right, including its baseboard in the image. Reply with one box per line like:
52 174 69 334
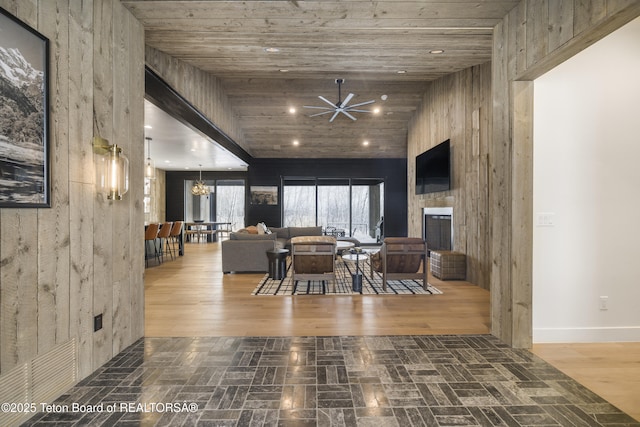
533 18 640 342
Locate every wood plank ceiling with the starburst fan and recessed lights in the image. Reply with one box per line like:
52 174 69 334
122 0 519 158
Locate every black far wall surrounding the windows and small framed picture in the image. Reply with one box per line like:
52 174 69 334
166 159 408 236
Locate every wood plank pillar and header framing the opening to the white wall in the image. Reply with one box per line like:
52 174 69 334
484 0 640 347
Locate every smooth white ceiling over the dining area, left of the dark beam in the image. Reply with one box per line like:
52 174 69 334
144 100 247 171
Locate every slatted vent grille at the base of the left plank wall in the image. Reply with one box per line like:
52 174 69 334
0 339 78 426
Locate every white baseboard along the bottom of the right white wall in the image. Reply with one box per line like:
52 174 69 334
533 326 640 344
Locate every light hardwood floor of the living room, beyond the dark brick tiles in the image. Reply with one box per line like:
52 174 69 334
145 243 489 337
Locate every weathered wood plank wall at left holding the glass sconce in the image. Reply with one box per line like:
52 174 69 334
0 0 144 379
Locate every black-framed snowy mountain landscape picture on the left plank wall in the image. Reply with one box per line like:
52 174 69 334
0 8 51 208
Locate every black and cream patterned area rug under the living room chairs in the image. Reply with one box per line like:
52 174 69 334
251 260 442 295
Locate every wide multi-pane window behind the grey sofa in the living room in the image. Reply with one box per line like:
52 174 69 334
282 178 384 243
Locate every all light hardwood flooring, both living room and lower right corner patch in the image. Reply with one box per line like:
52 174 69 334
145 243 640 420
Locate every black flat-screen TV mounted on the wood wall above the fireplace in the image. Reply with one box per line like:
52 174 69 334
416 139 451 194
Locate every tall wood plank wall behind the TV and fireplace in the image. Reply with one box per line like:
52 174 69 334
407 63 491 289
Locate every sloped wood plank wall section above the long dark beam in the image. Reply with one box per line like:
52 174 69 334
145 46 251 155
